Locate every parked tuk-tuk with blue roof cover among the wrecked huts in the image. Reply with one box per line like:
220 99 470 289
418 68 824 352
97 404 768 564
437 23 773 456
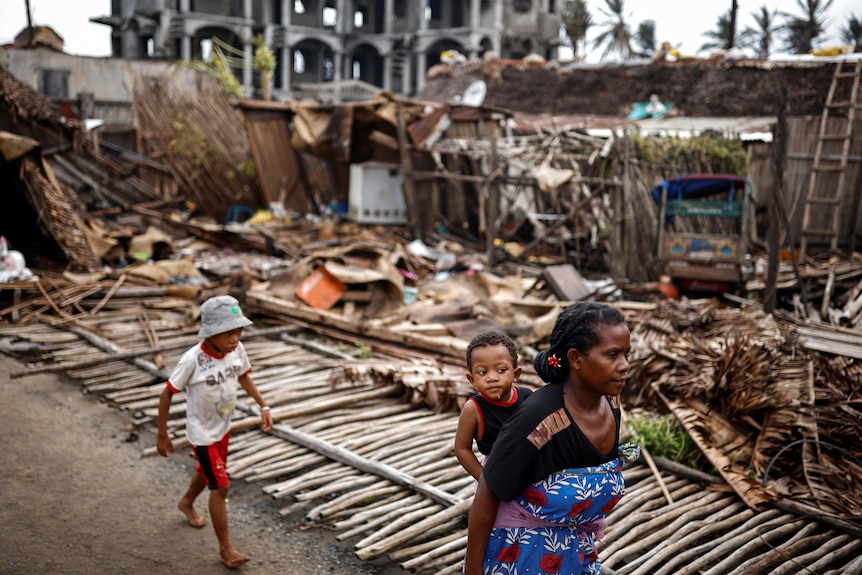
652 174 753 291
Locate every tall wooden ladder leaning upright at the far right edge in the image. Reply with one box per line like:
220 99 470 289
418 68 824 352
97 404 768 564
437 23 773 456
799 60 862 255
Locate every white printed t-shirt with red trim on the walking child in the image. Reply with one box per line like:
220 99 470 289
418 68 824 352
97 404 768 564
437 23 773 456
168 342 251 446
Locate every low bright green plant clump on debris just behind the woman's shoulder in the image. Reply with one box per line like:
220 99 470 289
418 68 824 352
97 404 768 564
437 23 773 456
627 411 705 469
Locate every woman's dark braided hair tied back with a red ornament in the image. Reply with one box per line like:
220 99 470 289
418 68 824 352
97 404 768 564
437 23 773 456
533 301 626 383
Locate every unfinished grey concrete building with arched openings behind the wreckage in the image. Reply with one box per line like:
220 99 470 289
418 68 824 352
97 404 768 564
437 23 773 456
90 0 563 99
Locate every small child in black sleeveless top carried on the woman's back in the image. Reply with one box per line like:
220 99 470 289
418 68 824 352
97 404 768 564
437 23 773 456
455 331 532 480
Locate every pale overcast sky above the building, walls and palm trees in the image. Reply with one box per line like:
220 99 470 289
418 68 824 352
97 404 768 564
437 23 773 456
0 0 862 56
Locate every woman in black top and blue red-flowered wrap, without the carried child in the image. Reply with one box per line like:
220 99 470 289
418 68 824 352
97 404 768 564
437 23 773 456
464 302 639 575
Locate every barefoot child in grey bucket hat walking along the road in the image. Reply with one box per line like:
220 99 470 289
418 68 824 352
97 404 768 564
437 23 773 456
156 296 272 569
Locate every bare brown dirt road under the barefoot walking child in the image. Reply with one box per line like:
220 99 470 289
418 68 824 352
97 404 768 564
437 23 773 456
0 354 405 575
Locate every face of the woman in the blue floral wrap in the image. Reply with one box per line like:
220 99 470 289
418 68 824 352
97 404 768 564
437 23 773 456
569 323 631 395
